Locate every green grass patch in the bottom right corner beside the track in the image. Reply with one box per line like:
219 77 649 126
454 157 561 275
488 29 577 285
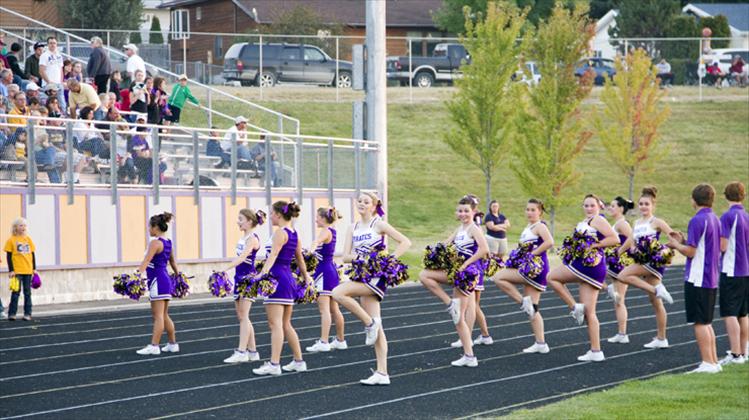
501 364 749 420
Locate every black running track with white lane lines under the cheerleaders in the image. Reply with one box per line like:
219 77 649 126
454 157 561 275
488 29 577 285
0 267 727 419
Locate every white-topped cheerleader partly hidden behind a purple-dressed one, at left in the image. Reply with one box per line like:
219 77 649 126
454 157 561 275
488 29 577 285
224 209 266 363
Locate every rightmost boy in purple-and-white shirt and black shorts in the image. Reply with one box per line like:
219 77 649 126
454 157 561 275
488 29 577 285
720 181 749 365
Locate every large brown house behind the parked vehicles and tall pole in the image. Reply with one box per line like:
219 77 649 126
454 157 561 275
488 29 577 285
160 0 447 64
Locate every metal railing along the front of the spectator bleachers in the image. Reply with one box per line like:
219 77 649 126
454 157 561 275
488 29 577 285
0 114 379 204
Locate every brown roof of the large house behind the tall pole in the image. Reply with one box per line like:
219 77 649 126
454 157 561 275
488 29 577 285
160 0 442 28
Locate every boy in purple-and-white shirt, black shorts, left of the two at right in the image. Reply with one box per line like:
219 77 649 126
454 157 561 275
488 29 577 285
668 184 721 373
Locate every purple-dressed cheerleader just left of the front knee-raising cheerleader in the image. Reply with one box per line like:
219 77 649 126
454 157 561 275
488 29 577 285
307 207 348 353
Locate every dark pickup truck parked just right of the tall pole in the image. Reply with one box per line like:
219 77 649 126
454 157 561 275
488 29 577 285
387 44 471 88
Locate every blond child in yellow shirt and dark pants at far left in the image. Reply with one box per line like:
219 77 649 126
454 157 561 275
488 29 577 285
4 218 36 321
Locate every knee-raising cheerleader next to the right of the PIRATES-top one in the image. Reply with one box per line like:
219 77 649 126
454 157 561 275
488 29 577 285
419 195 489 367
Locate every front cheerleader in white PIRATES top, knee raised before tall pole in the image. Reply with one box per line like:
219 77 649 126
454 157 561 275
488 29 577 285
333 192 411 385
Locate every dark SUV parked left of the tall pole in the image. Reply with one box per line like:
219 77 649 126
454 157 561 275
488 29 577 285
221 42 352 88
